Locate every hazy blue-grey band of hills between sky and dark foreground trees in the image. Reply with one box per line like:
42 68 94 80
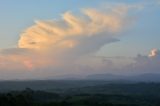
0 73 160 92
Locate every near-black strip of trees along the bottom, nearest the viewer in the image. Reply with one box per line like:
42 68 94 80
0 88 160 106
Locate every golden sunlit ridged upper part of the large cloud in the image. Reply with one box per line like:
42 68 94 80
18 9 126 49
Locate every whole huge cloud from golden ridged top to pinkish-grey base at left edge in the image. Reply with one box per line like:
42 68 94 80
0 3 151 77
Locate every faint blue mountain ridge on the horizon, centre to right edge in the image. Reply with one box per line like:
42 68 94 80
47 73 160 82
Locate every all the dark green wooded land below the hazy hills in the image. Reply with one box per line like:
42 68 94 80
0 81 160 106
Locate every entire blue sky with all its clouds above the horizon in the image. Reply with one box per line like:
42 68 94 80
0 0 160 79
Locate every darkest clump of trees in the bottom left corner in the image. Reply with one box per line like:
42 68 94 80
0 88 59 106
